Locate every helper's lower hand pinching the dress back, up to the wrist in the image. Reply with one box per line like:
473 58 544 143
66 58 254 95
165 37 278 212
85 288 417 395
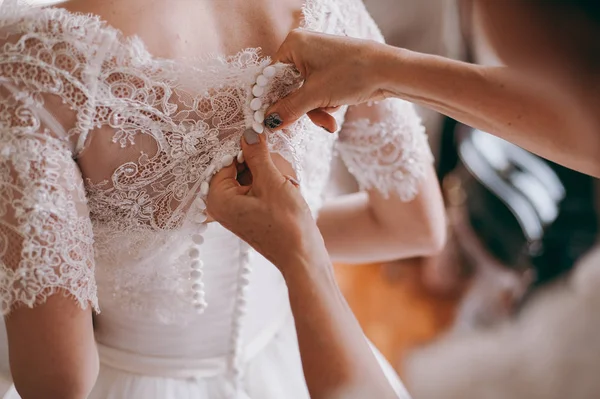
207 132 326 272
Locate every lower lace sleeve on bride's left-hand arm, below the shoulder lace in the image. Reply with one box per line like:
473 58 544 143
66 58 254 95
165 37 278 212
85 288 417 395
0 84 97 314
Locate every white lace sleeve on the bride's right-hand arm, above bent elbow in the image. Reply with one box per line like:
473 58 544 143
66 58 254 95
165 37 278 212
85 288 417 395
337 99 432 201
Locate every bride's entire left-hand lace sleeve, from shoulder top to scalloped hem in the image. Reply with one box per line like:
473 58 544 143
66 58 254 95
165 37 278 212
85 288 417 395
0 0 109 314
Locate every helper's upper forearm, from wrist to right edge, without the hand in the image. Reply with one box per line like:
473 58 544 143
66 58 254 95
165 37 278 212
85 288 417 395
378 47 600 176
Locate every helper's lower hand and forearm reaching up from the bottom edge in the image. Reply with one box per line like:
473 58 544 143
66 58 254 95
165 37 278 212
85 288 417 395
207 132 397 399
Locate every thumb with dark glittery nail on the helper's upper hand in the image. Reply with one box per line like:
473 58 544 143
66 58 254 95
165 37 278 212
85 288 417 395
265 80 320 130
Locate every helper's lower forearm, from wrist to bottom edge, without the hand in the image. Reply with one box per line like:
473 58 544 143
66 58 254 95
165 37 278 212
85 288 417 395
282 250 396 399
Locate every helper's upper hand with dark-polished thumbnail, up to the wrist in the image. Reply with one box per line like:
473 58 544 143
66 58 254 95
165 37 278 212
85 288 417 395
265 30 397 131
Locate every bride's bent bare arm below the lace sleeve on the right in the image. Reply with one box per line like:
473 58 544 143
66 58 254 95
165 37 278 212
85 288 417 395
317 168 446 264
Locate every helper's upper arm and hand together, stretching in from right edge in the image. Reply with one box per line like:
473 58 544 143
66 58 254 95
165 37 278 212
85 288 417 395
267 31 600 176
